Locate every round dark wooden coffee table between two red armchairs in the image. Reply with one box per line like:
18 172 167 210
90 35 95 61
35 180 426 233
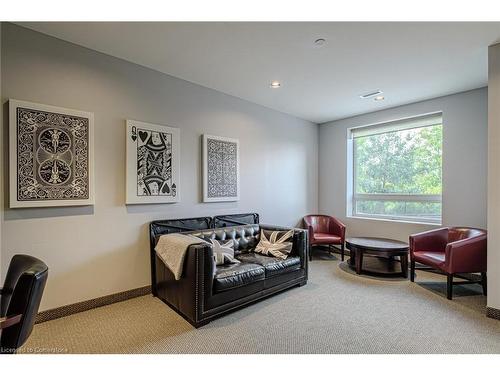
345 237 409 277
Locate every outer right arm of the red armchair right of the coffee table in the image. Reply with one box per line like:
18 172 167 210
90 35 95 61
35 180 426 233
445 235 487 273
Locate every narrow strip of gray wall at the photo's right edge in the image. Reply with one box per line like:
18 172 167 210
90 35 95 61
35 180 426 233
488 44 500 309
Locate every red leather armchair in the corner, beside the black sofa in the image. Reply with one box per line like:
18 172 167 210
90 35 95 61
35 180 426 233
304 215 345 261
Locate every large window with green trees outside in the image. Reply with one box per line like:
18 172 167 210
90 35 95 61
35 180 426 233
347 113 443 224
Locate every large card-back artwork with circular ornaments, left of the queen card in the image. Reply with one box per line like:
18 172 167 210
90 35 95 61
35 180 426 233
9 99 94 208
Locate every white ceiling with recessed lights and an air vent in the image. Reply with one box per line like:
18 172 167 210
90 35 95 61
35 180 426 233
19 22 500 123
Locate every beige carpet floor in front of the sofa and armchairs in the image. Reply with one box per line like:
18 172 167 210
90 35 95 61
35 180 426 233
22 255 500 353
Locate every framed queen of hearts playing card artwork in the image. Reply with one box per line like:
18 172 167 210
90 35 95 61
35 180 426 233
127 120 179 204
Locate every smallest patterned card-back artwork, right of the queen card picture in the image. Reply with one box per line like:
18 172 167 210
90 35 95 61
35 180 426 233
203 134 240 202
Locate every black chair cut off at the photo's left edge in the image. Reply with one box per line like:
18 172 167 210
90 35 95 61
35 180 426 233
0 255 49 354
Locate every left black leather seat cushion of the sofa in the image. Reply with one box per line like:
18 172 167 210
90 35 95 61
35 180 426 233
214 262 265 292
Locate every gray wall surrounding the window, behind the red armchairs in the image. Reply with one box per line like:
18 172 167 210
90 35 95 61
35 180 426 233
319 88 488 244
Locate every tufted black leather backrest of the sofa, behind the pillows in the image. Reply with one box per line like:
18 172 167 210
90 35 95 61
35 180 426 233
184 224 260 254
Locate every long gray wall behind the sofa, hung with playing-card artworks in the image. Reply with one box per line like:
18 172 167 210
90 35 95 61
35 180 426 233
1 24 318 310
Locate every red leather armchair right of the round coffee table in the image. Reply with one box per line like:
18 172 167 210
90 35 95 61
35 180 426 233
410 227 486 299
